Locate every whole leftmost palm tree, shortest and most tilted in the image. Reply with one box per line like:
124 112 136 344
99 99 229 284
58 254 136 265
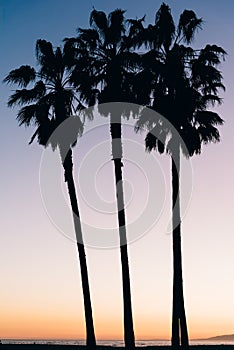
4 40 96 347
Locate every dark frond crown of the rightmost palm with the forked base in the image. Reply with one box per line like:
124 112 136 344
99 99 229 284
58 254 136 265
135 4 226 156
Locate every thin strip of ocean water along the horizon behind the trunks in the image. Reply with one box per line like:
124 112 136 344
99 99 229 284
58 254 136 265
1 339 234 347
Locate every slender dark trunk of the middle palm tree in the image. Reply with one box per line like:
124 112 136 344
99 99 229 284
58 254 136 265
110 113 135 349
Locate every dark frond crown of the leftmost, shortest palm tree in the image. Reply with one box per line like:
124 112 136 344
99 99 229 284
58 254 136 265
4 40 83 149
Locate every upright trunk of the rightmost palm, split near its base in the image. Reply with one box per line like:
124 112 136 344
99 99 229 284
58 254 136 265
172 145 189 349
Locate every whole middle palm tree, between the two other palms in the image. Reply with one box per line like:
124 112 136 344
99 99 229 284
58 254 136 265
67 9 139 348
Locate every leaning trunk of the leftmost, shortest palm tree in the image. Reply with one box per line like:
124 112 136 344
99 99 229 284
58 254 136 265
62 149 96 348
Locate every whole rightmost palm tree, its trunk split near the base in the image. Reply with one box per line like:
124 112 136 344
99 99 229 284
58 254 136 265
135 3 226 349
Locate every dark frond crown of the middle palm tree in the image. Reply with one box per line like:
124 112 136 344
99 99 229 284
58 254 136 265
66 9 140 111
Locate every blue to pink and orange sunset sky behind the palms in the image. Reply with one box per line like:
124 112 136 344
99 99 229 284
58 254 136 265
0 0 234 340
